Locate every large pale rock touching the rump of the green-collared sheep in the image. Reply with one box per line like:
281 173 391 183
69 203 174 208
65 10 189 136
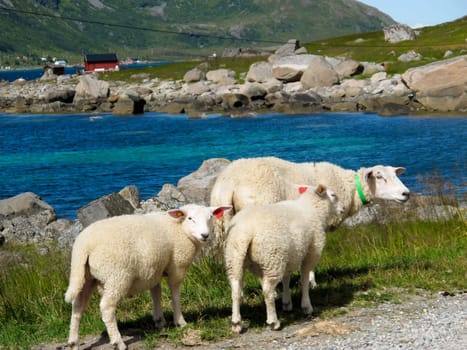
177 158 230 205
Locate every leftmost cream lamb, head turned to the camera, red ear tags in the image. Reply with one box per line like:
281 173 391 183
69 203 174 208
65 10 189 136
65 204 231 350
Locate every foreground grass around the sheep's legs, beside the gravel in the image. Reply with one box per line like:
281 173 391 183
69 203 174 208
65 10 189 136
0 197 467 348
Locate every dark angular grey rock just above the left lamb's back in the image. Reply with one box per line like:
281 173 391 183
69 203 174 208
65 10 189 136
78 193 135 227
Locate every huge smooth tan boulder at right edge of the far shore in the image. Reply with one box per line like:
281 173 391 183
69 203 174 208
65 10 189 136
402 55 467 111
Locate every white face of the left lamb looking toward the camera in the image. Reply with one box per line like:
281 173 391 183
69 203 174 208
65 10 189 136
168 204 232 242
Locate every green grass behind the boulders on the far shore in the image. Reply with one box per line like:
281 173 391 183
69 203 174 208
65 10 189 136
97 17 467 82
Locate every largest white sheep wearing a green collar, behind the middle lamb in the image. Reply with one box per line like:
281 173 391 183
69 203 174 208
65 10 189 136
210 157 410 287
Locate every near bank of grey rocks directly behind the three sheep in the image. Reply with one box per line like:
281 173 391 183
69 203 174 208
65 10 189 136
0 158 460 250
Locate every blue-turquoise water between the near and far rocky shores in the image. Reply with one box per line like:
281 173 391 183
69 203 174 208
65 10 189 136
0 113 467 218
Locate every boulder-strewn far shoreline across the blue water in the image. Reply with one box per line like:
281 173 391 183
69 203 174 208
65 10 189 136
0 40 467 118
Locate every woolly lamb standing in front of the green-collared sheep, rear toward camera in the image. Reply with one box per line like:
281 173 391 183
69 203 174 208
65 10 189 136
224 185 344 333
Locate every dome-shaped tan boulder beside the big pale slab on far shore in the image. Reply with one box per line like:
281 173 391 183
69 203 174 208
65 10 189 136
300 57 339 89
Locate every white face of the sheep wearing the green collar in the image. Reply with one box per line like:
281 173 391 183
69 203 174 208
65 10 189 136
365 165 410 202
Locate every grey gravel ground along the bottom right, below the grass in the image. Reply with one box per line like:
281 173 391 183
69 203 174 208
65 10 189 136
35 291 467 350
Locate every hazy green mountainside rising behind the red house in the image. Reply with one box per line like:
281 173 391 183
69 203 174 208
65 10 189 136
0 0 395 65
